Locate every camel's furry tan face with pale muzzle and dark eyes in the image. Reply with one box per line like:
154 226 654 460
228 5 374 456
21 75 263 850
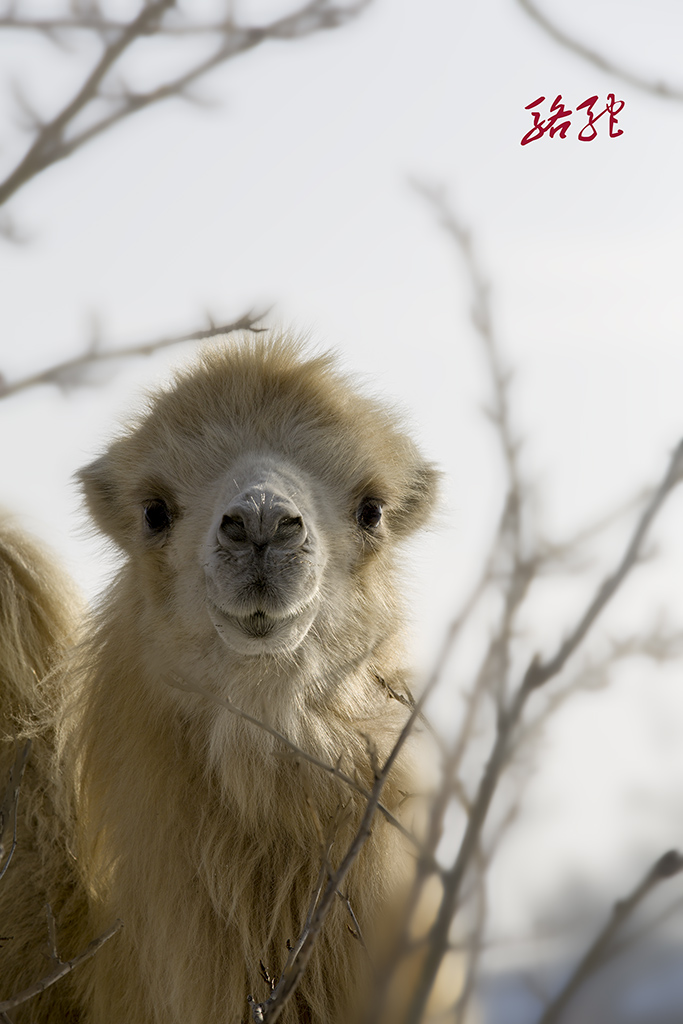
81 337 437 721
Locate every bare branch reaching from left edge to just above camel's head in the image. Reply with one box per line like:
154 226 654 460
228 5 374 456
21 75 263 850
0 310 267 399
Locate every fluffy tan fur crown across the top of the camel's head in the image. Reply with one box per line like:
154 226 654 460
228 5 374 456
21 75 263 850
81 333 436 548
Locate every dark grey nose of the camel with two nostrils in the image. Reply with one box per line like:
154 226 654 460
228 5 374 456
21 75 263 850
217 486 307 550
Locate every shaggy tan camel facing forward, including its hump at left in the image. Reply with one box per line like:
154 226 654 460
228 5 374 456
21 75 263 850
0 336 436 1024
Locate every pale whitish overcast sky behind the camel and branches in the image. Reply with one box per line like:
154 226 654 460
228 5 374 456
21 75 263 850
0 0 683 958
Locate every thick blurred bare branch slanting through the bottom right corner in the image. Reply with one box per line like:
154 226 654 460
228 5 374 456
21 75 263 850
539 850 683 1024
